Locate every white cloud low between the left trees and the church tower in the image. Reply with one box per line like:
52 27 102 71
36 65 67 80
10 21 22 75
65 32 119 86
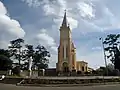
36 29 57 67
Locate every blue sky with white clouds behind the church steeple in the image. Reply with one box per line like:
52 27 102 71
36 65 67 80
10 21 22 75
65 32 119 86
0 0 120 68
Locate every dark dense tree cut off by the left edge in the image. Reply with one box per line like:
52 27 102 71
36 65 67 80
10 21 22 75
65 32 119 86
0 49 12 70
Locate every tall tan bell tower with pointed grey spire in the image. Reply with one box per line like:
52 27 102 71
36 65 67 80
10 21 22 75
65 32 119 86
57 11 76 72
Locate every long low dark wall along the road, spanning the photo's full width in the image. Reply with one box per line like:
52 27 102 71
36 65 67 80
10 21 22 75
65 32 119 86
0 77 120 84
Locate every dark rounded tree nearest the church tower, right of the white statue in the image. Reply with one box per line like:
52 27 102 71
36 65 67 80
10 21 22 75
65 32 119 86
33 45 50 69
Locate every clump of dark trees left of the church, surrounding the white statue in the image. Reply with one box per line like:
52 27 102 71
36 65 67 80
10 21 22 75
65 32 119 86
6 38 50 69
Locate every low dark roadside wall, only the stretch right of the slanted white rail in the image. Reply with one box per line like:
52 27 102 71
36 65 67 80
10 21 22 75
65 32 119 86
21 77 120 84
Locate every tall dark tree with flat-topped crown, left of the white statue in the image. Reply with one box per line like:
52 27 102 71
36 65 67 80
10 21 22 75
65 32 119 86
8 38 24 66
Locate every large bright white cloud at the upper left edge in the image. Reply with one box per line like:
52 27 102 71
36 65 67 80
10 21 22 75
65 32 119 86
0 2 25 37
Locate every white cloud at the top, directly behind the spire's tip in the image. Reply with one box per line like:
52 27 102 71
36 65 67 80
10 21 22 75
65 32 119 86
23 0 78 29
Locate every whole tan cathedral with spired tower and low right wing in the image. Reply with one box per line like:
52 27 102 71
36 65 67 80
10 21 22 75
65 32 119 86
56 12 88 72
